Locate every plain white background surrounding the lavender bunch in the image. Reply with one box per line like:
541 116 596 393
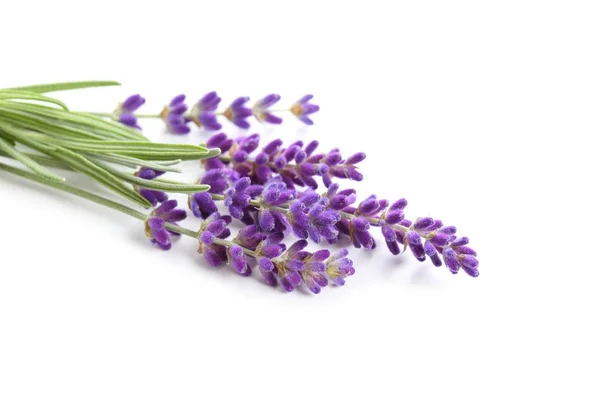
0 0 600 400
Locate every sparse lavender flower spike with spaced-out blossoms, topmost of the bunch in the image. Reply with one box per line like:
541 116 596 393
112 91 319 134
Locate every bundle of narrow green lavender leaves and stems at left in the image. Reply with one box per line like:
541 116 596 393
0 81 220 208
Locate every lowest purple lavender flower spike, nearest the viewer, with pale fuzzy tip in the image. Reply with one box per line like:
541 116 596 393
141 191 354 293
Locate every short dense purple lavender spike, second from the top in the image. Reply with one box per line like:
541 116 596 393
203 133 366 189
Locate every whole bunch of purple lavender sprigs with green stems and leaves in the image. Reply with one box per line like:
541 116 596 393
0 81 479 293
